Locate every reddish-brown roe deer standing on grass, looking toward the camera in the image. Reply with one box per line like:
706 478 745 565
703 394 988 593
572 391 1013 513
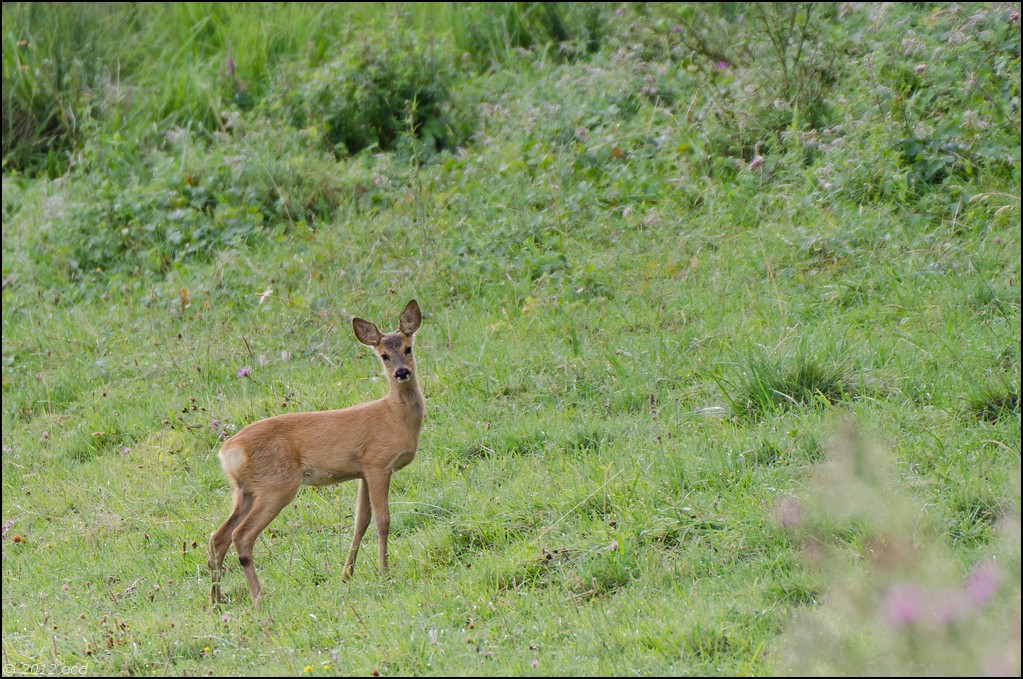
210 300 424 605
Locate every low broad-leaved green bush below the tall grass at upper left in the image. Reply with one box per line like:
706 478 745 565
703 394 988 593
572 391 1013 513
31 120 358 278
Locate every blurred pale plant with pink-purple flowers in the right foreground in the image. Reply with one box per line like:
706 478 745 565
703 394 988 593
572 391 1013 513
776 422 1020 676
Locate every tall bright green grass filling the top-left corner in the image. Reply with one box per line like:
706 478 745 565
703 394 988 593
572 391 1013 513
3 2 464 178
